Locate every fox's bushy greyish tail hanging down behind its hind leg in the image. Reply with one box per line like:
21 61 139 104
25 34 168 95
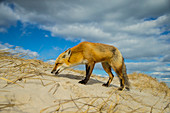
122 58 130 88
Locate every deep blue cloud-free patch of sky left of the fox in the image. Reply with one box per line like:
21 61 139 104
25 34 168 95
0 21 80 61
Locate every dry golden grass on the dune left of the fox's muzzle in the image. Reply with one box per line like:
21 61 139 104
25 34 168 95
0 50 52 84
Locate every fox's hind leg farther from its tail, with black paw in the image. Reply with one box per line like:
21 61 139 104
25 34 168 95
102 62 114 87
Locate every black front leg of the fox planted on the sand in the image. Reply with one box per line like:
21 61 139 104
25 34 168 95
79 63 95 84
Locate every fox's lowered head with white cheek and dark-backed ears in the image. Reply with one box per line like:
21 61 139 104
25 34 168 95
51 49 71 74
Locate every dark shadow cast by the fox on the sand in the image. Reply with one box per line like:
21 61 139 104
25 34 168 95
55 74 118 88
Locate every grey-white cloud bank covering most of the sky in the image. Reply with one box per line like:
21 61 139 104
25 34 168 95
0 0 170 81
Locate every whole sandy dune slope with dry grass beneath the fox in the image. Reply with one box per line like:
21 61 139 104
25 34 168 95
0 51 170 113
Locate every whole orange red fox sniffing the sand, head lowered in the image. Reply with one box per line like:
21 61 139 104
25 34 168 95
51 42 129 90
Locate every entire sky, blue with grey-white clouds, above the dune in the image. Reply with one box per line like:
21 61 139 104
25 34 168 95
0 0 170 85
